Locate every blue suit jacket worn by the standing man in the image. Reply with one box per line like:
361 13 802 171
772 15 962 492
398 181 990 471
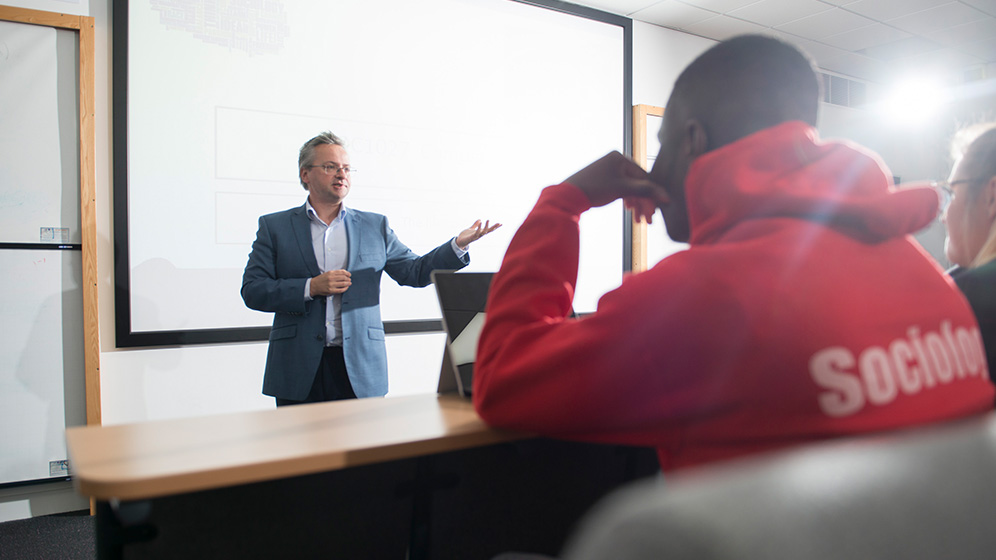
242 205 469 400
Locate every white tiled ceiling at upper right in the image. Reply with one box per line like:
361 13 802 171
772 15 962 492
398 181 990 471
569 0 996 83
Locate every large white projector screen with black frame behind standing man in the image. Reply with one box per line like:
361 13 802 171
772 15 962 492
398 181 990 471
114 0 631 346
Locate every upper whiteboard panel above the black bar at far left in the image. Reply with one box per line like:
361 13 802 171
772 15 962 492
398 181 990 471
0 21 81 244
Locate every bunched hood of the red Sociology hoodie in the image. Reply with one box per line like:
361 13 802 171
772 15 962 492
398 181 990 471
685 121 939 245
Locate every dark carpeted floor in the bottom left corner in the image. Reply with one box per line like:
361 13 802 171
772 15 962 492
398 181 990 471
0 512 97 560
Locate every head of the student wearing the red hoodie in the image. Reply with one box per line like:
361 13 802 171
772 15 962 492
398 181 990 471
650 35 820 241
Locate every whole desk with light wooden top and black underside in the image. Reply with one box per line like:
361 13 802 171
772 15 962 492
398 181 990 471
66 395 660 558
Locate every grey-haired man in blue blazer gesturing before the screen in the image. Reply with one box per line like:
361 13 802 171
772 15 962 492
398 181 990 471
241 132 501 406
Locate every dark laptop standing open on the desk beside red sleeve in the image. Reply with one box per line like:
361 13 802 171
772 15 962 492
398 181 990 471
432 270 494 397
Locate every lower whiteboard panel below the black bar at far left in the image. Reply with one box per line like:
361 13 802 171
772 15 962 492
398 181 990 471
0 249 86 484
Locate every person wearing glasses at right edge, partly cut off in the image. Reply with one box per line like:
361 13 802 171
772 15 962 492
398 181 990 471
941 123 996 379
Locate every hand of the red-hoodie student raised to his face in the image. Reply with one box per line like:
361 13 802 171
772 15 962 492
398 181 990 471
567 152 669 223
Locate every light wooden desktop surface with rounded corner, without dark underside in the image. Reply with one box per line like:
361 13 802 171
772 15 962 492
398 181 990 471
66 395 528 500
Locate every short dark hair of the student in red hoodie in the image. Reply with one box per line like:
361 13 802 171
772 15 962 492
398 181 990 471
672 35 820 149
